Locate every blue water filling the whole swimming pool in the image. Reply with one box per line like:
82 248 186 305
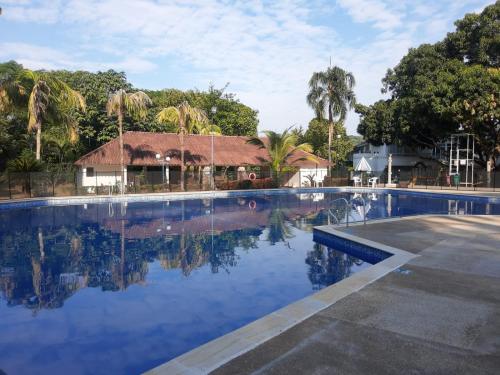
0 193 500 374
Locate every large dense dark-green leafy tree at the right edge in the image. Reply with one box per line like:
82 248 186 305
356 2 500 163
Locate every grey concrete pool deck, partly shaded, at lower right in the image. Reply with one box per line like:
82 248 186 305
213 216 500 375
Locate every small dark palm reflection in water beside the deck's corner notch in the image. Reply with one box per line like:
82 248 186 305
306 244 363 290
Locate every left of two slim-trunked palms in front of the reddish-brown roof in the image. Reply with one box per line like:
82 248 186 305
106 89 152 194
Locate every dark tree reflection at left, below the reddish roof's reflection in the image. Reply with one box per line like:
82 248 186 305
0 223 261 312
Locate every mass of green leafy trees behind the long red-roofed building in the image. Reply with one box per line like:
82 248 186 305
0 61 258 170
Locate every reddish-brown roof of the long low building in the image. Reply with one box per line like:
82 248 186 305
75 132 328 168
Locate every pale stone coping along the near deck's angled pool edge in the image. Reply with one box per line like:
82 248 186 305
144 219 418 375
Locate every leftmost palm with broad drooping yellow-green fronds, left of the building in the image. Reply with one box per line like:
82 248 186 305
0 69 85 160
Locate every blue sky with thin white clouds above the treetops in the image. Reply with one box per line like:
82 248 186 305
0 0 493 134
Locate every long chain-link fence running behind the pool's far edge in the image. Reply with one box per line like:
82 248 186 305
0 168 500 199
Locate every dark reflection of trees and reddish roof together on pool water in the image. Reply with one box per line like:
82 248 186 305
0 196 340 311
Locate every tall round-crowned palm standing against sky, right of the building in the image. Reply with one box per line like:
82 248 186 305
307 66 356 173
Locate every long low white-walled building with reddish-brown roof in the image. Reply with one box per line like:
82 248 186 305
75 131 328 188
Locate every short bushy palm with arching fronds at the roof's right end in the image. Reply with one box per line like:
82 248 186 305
247 128 317 183
